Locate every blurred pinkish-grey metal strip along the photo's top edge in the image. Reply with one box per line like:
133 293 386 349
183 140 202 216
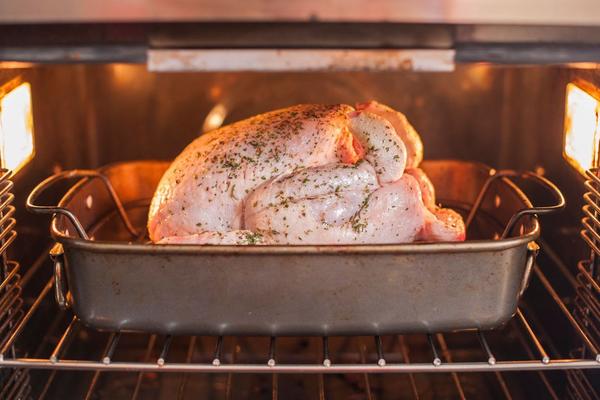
0 0 600 26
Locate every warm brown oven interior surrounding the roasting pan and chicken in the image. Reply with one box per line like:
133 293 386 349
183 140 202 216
0 63 600 399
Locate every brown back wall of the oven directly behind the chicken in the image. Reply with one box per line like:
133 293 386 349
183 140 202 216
67 65 506 165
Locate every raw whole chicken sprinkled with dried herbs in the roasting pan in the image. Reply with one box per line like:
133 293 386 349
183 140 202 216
148 101 465 244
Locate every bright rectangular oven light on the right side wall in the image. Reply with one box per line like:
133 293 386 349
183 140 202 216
564 83 600 173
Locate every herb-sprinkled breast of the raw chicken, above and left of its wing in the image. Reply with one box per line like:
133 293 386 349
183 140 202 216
148 105 358 242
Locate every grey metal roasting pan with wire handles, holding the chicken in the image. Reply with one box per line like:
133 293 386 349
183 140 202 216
27 160 564 336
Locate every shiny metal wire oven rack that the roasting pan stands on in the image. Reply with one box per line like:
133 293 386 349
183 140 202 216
0 266 600 380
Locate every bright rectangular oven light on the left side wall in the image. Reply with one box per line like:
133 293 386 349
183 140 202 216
0 82 34 173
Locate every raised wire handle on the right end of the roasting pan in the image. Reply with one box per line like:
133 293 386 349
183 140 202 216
465 169 566 239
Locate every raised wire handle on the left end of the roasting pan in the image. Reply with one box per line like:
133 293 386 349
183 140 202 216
26 169 138 240
